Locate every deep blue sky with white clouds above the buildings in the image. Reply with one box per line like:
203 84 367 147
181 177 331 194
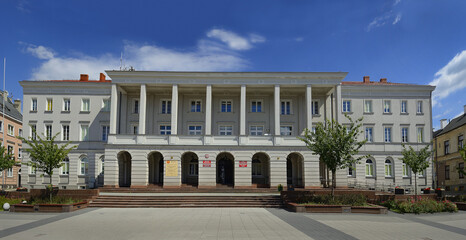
0 0 466 127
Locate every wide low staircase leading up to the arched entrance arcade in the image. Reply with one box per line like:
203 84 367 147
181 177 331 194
89 194 283 208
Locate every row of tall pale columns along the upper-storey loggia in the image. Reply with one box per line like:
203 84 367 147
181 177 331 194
110 84 312 136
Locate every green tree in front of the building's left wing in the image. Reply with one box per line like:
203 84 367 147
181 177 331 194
18 128 77 201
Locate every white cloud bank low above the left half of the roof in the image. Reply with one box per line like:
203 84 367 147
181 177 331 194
20 29 258 80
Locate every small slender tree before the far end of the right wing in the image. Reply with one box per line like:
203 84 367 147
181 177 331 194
400 144 431 201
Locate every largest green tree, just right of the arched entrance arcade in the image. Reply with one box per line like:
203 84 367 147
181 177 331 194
298 114 368 198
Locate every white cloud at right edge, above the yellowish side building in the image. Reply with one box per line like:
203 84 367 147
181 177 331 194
429 50 466 107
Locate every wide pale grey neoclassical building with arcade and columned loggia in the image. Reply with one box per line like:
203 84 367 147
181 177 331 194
20 71 434 192
